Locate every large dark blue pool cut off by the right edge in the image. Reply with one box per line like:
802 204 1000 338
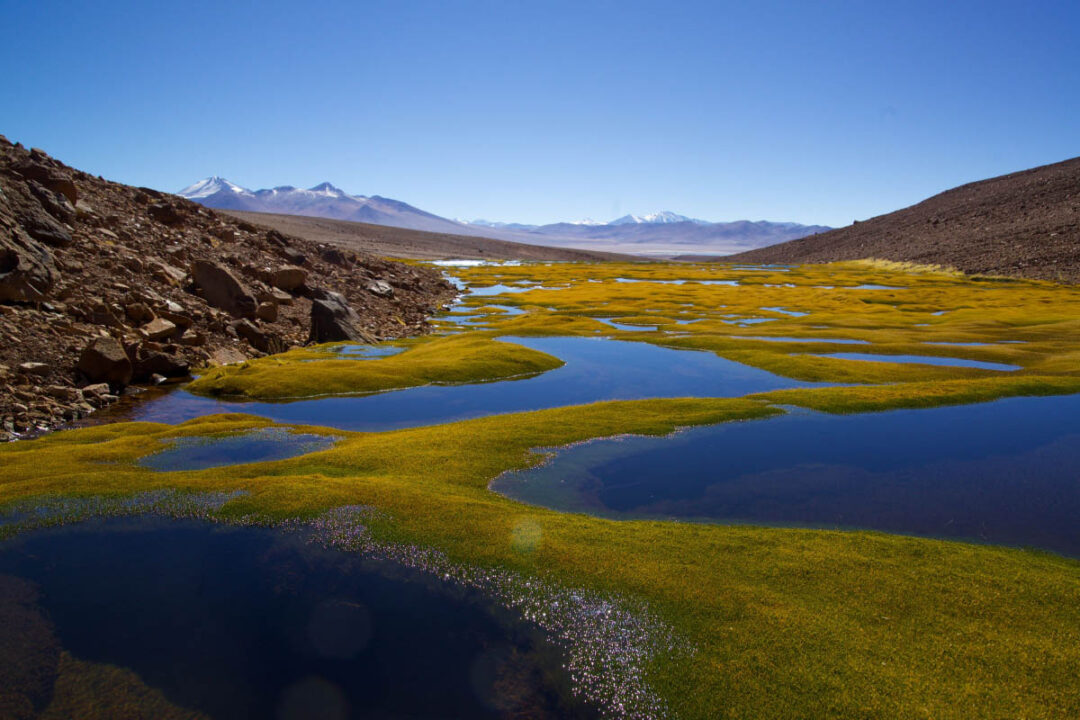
492 395 1080 556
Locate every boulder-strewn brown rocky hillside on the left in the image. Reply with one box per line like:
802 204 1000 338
0 136 454 439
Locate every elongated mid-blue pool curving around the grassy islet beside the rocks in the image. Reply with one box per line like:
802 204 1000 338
122 338 813 431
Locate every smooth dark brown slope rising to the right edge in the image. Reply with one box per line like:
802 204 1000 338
724 158 1080 283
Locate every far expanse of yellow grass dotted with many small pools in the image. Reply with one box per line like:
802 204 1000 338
438 260 1080 405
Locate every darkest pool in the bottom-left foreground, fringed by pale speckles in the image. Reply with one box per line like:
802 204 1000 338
0 517 594 720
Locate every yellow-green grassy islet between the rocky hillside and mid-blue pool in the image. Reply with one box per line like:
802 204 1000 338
188 334 563 400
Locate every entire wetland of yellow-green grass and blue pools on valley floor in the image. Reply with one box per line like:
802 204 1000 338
0 261 1080 720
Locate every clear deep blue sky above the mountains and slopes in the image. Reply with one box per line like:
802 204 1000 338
0 0 1080 226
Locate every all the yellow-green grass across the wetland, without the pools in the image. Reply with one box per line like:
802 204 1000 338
6 262 1080 718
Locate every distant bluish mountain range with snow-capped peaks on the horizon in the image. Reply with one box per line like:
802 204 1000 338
177 177 831 255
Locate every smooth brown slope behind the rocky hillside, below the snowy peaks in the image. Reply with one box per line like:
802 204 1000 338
216 210 644 262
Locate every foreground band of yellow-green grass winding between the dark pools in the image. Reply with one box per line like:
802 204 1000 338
0 399 1080 719
